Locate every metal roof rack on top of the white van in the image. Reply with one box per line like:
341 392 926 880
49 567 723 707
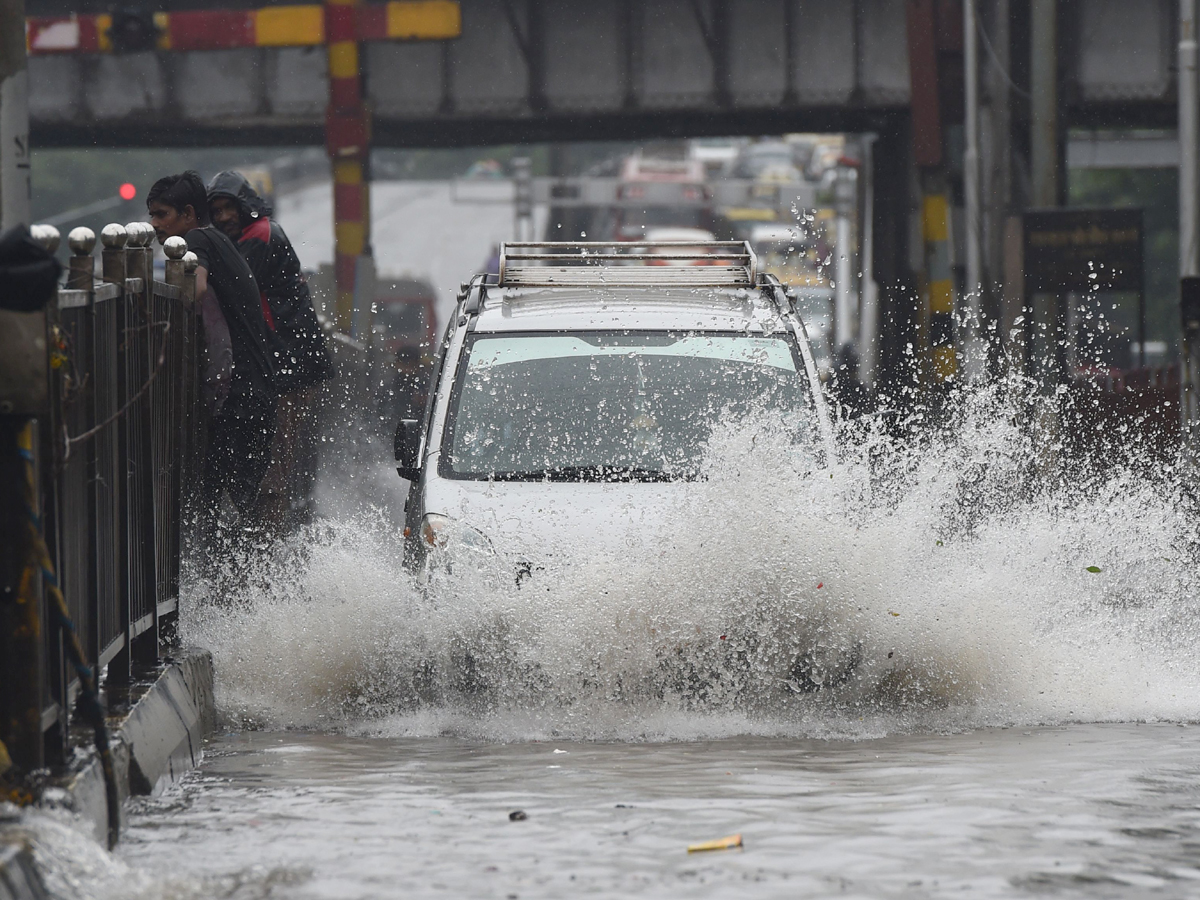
499 241 758 288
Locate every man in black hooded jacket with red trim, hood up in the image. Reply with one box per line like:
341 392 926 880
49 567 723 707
208 172 334 526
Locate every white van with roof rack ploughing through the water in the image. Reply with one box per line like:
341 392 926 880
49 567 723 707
395 240 833 571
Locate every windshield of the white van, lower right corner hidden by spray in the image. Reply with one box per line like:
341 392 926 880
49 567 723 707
442 331 816 481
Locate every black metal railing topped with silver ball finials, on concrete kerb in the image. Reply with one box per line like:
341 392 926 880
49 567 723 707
34 223 206 761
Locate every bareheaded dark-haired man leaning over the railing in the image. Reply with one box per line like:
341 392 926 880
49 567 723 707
146 172 278 548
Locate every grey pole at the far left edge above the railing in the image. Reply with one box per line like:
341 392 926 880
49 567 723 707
0 0 30 228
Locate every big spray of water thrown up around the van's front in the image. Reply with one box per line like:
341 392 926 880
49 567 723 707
184 379 1200 739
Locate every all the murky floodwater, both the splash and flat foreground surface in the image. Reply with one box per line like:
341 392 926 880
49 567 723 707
18 383 1200 900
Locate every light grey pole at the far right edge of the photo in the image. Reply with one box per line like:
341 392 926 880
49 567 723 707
1178 0 1200 457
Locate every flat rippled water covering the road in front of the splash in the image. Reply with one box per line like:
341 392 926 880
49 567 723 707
120 725 1200 899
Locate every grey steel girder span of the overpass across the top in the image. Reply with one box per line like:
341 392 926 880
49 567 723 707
26 0 1176 146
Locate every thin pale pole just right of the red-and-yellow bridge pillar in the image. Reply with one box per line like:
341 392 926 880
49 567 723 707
962 0 988 380
